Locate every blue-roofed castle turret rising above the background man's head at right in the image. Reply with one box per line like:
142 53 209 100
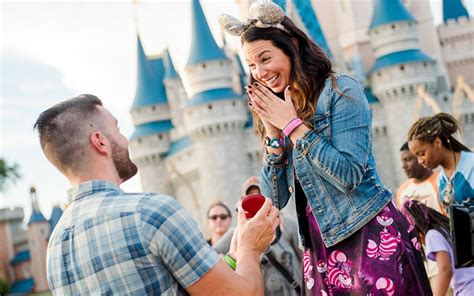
369 0 437 184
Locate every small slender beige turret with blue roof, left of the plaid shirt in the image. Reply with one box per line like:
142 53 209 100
27 187 51 292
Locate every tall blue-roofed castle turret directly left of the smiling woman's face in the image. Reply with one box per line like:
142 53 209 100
183 0 251 208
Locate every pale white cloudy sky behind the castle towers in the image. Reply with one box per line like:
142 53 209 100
0 0 474 218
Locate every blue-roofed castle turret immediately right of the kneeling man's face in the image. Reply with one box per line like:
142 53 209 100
130 37 173 194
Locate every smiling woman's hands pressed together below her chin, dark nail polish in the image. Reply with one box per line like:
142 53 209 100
247 82 297 133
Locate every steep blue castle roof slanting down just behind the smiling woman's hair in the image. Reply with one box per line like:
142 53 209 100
293 0 331 56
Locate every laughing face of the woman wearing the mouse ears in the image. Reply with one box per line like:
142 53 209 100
242 40 291 93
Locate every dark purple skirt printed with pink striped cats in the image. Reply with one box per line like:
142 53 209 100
303 202 432 296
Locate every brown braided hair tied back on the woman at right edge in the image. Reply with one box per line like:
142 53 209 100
408 113 470 152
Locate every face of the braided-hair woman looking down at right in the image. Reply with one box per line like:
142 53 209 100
408 138 442 169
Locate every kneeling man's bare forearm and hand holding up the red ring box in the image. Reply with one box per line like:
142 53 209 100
186 198 280 295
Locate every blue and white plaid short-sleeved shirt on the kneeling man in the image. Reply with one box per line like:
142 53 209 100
46 180 219 295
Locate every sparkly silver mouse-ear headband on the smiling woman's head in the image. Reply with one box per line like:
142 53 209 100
219 0 291 36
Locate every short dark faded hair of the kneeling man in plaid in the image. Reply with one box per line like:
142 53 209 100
33 94 102 172
